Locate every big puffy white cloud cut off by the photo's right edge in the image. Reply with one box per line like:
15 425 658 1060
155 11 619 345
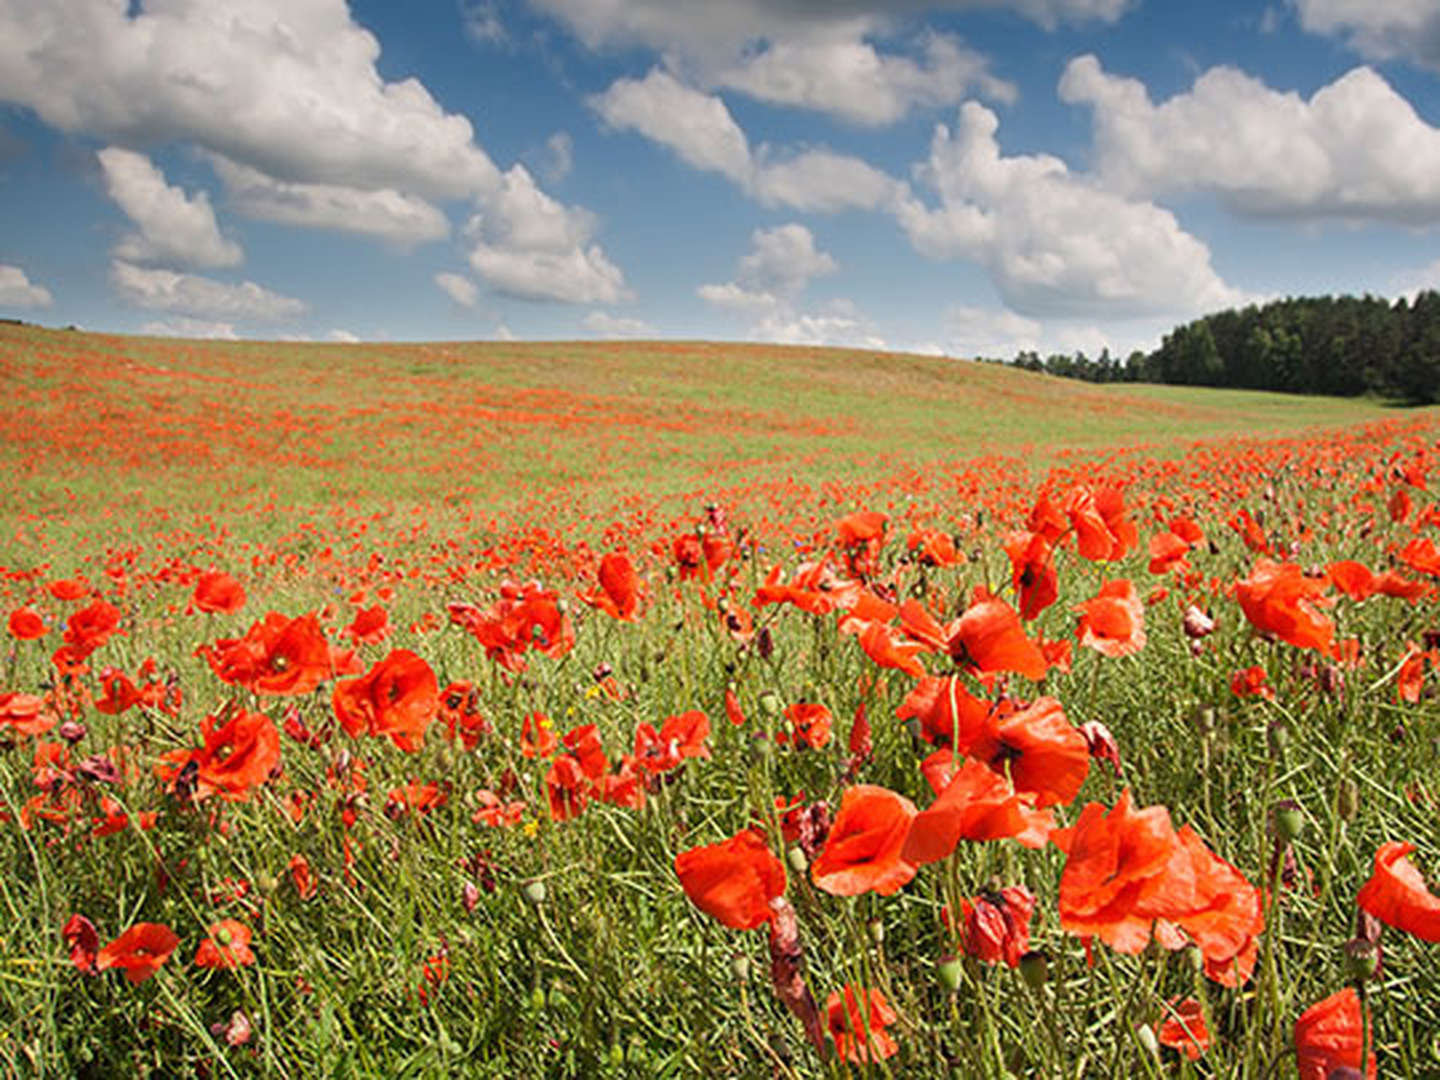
1060 56 1440 225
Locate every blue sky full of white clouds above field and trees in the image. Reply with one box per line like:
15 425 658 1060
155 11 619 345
0 0 1440 359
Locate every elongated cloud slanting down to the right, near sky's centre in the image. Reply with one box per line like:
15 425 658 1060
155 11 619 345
590 68 904 213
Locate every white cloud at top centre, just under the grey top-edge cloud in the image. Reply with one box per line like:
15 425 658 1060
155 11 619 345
714 33 1015 127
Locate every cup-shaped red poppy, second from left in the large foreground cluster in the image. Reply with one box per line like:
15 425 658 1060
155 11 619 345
811 783 914 896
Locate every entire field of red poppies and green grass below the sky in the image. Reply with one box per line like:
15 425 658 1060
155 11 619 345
0 325 1440 1080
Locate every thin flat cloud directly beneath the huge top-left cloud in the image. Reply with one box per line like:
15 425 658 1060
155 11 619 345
210 154 449 246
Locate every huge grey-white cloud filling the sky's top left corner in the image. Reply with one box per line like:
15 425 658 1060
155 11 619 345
0 0 500 197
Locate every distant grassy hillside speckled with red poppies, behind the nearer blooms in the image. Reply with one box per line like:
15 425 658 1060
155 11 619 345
0 325 1405 532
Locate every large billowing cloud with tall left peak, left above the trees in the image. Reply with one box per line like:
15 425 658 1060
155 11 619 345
896 102 1238 317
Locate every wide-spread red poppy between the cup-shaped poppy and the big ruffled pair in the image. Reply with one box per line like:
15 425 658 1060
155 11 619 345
901 750 1054 865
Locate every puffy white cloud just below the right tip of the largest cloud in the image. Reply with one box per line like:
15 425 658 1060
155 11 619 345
465 166 629 304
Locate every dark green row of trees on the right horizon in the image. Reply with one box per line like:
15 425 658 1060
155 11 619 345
1012 291 1440 405
